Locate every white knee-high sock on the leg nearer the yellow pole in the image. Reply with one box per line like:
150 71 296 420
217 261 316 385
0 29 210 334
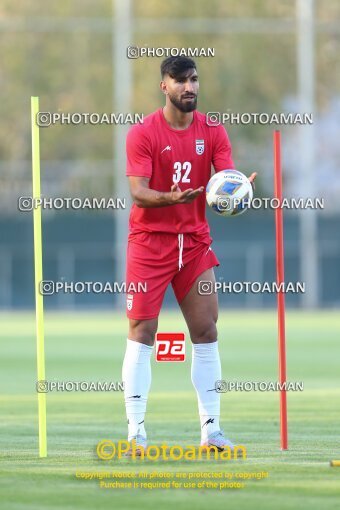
122 339 153 441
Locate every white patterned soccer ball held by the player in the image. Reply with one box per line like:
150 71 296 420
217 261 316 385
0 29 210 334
206 170 253 216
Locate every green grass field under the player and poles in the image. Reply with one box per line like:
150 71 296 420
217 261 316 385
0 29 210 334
0 312 340 510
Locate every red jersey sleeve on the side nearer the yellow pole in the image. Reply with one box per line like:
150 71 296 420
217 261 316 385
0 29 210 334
126 125 152 178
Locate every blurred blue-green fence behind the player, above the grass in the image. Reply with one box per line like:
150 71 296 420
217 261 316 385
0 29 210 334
0 211 340 310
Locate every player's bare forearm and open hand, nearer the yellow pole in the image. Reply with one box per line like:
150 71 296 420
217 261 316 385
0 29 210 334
129 176 204 207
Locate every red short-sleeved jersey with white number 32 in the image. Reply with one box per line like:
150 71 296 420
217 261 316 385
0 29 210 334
126 108 234 235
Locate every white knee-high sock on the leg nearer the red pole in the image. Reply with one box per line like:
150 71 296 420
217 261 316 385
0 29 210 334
191 341 221 442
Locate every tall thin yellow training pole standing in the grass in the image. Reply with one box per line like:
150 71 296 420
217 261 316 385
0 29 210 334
31 97 47 457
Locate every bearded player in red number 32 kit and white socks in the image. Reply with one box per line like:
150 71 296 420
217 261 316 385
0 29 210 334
122 57 256 450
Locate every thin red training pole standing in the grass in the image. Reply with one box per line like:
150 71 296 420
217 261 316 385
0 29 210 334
274 131 288 450
